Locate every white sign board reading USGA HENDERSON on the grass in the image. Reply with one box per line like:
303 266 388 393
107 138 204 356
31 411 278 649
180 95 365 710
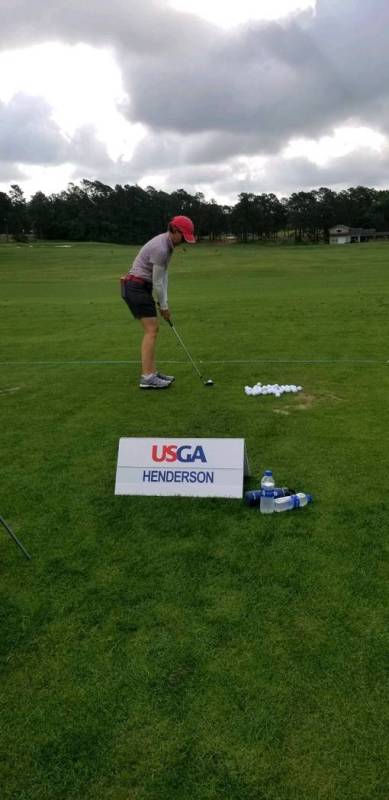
115 438 249 497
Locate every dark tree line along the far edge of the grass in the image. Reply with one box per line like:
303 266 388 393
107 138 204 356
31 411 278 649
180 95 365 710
0 180 389 244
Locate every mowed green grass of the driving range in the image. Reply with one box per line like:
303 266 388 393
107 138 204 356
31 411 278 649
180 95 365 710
0 244 389 800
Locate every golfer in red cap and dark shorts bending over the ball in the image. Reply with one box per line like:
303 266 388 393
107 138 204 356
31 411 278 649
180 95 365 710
121 216 196 389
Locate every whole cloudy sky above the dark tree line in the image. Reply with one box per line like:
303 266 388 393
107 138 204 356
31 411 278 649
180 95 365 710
0 0 389 203
